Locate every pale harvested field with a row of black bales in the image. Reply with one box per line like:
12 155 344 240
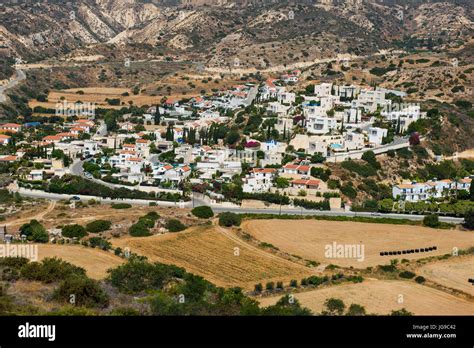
242 219 474 268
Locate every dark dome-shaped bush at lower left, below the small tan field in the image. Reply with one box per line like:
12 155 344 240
53 275 109 308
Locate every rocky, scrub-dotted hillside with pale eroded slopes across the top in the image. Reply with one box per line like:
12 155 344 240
0 0 474 67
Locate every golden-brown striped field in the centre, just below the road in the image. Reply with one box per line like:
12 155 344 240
112 226 312 289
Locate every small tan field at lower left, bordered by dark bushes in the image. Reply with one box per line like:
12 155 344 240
38 244 124 279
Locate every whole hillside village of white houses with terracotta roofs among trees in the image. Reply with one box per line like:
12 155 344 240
0 75 472 210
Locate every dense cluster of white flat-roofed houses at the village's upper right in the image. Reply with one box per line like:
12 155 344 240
258 79 424 156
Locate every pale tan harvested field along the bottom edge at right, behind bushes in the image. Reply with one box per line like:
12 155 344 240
258 280 474 315
